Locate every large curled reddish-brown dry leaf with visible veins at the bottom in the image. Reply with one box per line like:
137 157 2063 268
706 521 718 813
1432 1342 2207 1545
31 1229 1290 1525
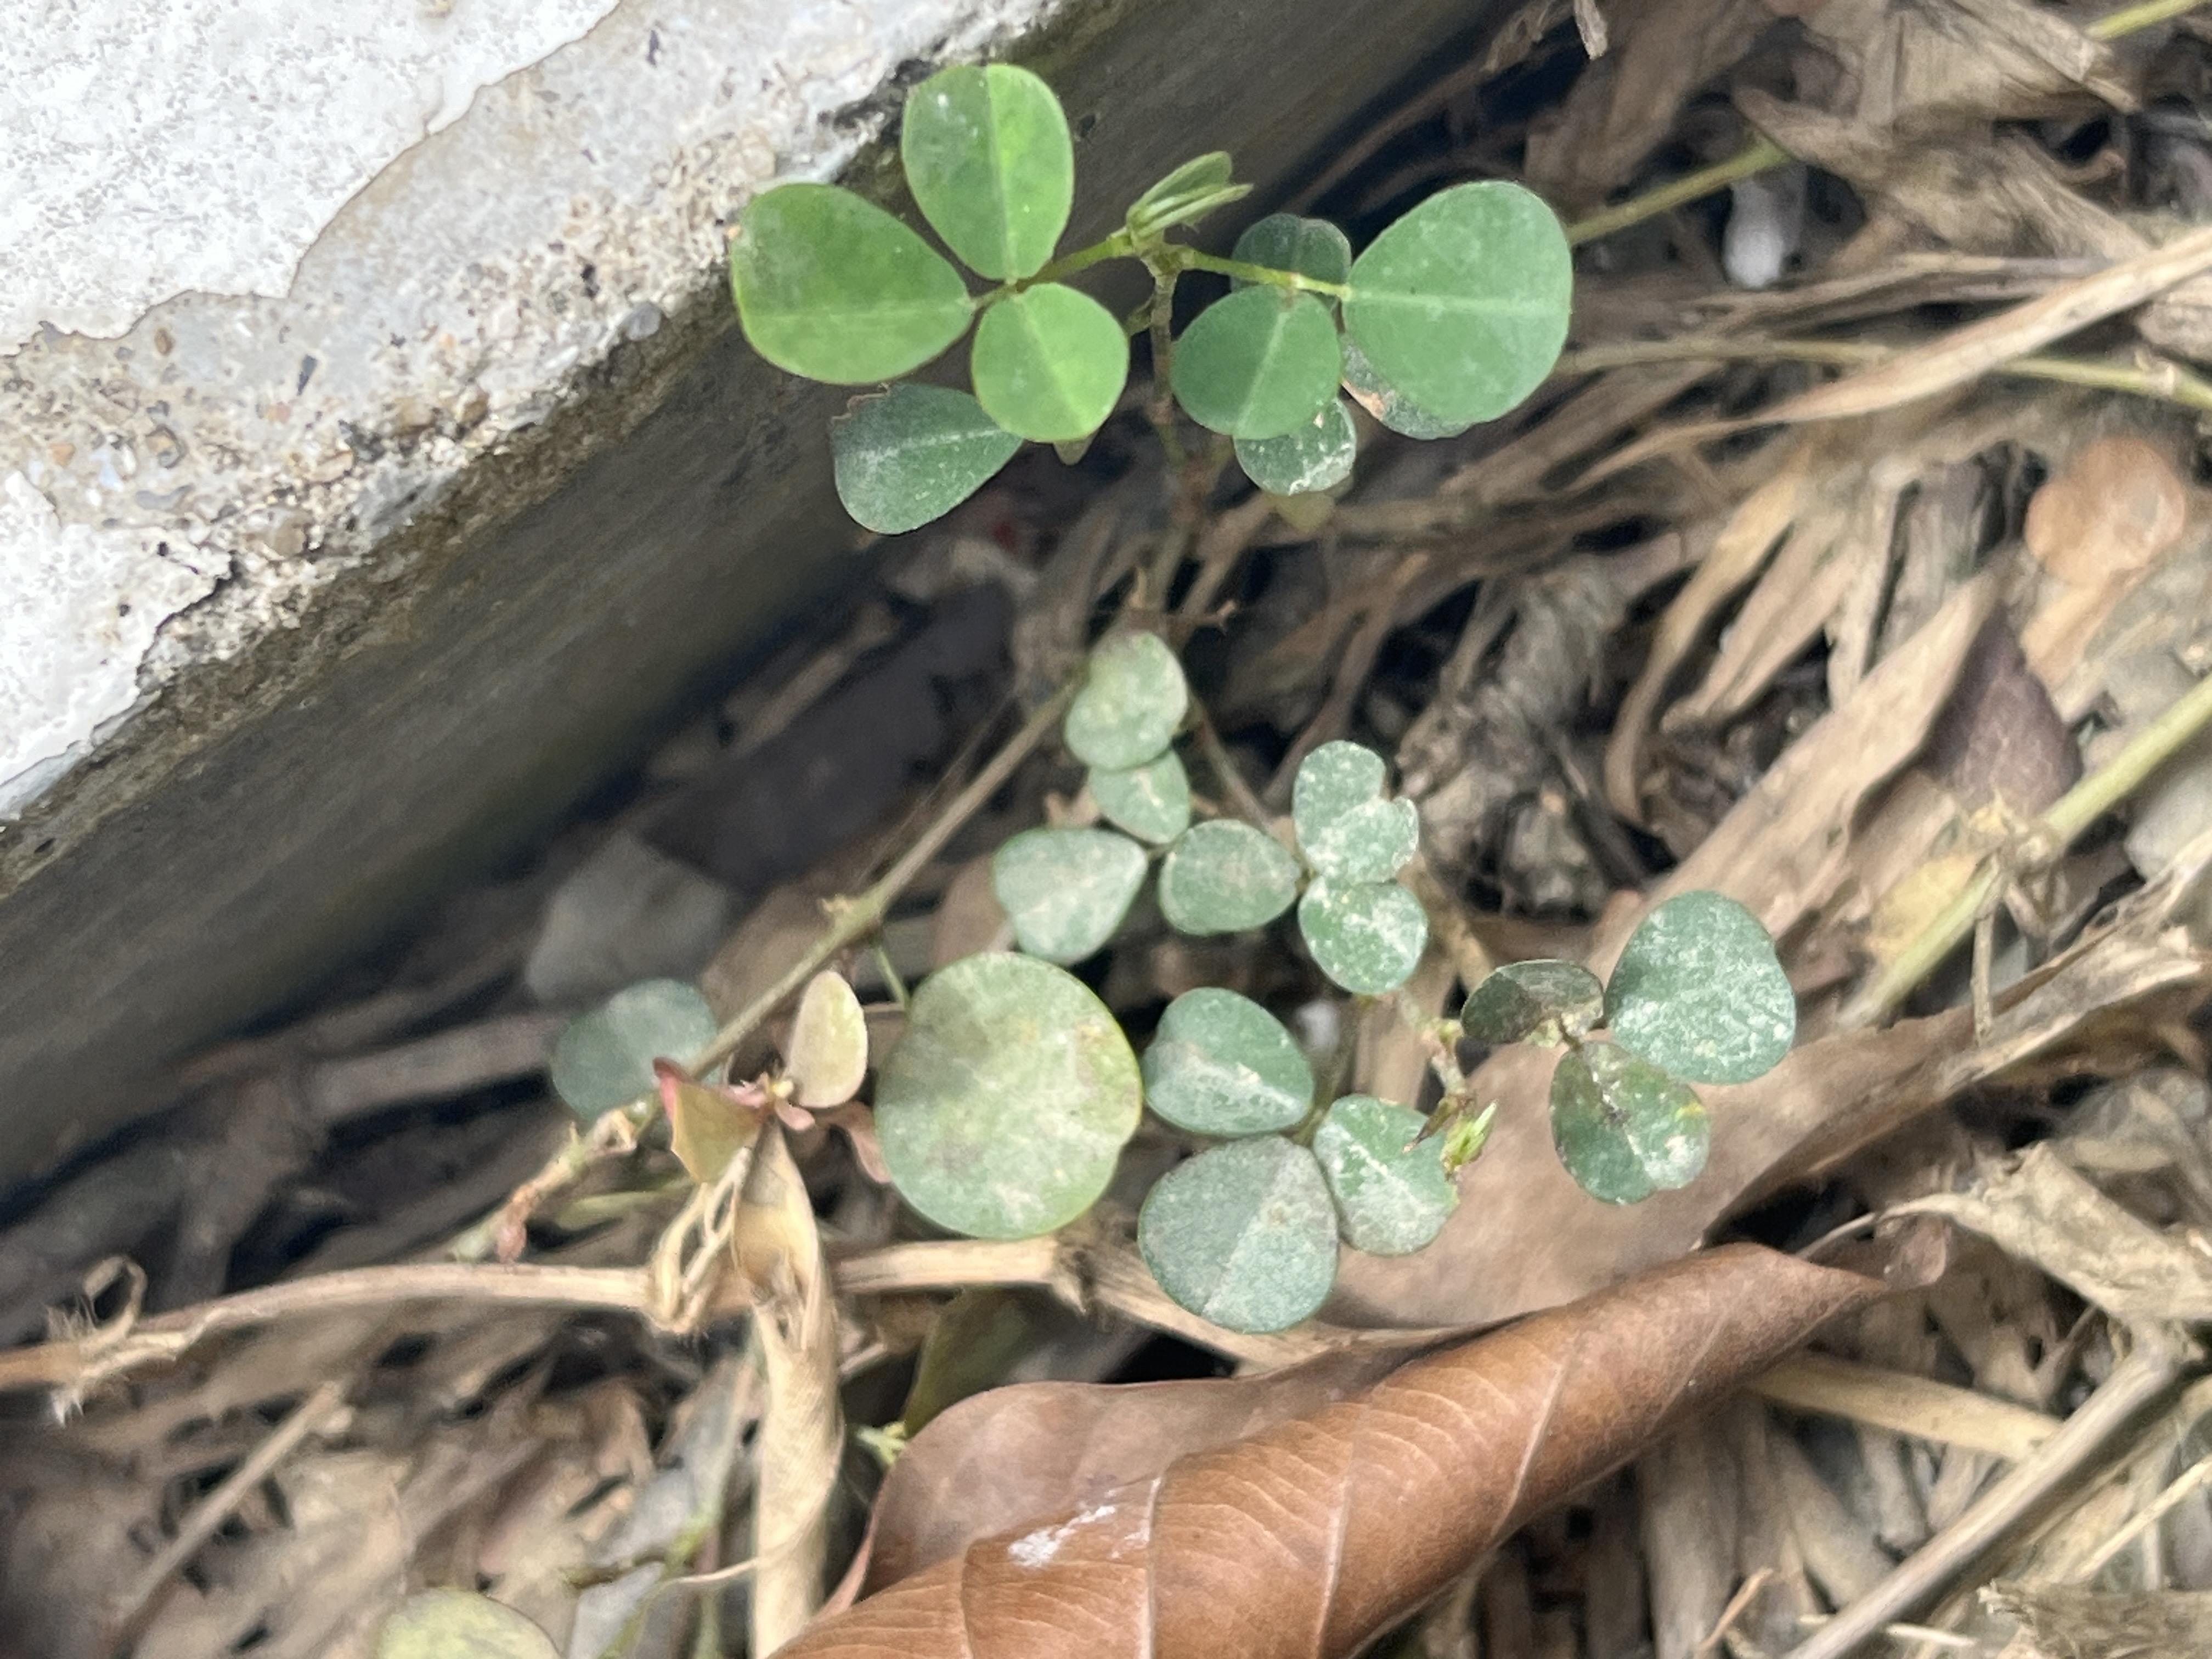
785 1245 1880 1659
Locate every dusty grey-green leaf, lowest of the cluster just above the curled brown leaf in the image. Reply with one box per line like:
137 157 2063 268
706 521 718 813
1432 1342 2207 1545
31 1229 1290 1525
1137 1135 1336 1331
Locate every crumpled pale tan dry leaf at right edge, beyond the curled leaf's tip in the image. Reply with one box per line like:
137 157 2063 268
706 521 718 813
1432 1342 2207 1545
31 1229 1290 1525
1893 1144 2212 1325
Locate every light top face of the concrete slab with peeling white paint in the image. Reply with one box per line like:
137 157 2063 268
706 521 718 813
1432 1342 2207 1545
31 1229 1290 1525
0 0 1053 827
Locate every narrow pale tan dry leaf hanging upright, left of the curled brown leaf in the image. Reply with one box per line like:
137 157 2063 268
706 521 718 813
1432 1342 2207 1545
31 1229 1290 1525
730 1126 845 1652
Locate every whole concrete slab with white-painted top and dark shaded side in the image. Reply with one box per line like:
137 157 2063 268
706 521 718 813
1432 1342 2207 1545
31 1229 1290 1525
0 0 1482 1183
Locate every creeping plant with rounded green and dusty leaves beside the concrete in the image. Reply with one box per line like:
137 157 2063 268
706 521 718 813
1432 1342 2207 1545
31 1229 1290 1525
553 64 1796 1331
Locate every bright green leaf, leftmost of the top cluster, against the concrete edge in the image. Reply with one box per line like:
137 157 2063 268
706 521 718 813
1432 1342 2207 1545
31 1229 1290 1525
730 184 973 385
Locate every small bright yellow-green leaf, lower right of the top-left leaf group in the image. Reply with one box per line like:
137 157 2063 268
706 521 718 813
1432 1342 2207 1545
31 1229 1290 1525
969 283 1128 444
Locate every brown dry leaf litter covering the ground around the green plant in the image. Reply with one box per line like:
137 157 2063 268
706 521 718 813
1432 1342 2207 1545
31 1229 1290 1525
0 0 2212 1659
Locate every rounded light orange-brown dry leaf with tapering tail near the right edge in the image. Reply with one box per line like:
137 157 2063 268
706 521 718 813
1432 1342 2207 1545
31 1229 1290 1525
2019 436 2190 688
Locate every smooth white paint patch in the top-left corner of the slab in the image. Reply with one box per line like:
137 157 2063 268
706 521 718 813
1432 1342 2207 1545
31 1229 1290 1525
0 0 615 352
